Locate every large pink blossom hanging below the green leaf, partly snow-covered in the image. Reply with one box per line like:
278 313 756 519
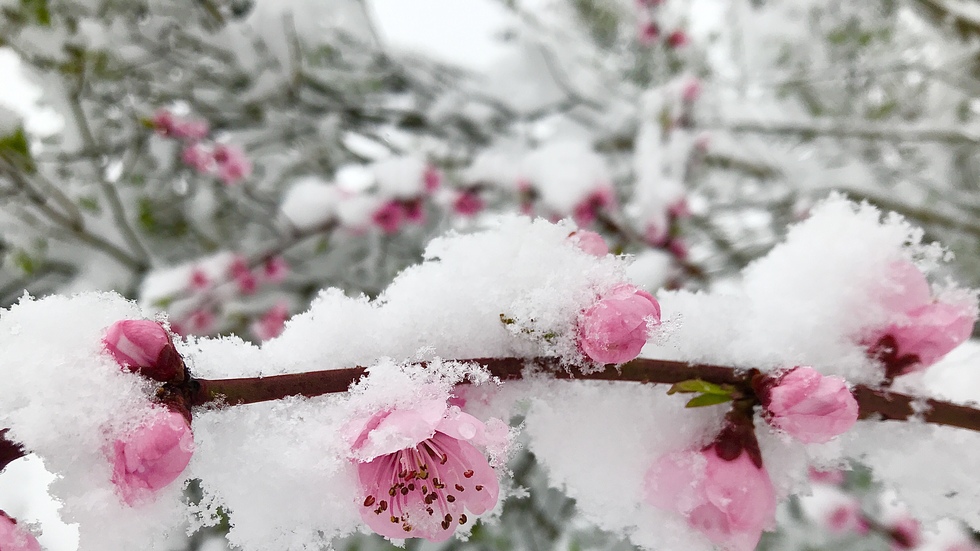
644 444 776 551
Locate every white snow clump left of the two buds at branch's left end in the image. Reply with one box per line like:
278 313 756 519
0 293 184 550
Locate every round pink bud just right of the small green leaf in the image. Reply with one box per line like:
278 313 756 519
756 366 858 444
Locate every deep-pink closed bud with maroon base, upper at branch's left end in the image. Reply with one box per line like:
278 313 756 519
102 320 184 382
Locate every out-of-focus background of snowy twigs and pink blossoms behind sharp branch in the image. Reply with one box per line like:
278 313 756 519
0 0 980 551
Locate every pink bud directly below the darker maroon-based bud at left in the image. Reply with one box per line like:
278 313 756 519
111 407 194 505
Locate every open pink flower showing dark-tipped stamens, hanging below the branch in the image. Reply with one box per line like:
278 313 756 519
345 400 506 541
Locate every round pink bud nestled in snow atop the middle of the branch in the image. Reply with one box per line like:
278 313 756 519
578 283 660 363
